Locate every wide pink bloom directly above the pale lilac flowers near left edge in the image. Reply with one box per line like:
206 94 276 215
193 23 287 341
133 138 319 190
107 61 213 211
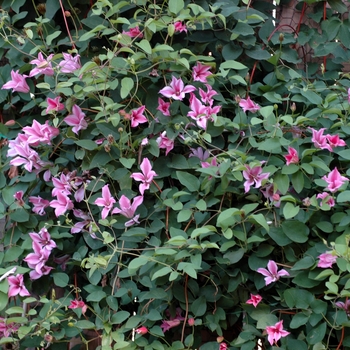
22 119 60 147
